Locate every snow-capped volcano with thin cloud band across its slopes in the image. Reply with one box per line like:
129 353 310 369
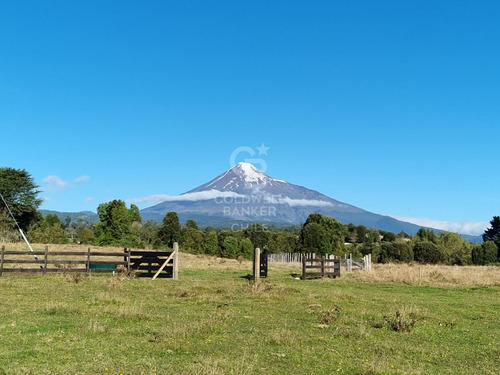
141 163 430 234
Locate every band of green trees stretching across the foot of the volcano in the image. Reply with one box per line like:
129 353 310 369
0 168 500 265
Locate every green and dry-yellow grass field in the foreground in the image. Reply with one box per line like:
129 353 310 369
0 245 500 375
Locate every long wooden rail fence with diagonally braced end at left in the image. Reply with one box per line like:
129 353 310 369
0 244 179 279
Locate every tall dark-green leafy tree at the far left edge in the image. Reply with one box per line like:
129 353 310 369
0 168 42 231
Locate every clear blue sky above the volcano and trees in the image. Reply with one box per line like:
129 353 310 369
0 0 500 232
